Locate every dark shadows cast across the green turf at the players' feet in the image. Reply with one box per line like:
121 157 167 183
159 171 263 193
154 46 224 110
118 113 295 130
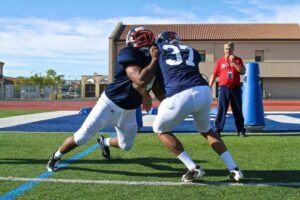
0 157 300 182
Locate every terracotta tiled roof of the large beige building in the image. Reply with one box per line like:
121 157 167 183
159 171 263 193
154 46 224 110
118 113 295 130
115 24 300 41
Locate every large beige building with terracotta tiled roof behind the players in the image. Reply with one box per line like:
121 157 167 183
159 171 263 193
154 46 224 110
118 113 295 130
109 23 300 99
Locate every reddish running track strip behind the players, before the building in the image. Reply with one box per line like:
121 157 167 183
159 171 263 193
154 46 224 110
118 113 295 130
0 99 300 111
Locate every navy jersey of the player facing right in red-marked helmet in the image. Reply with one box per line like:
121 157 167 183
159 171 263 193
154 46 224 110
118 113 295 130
105 47 151 110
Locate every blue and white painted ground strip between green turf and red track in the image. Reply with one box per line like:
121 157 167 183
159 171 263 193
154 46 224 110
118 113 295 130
0 110 300 133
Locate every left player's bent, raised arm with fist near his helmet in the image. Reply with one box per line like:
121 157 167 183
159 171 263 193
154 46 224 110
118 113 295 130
126 46 158 87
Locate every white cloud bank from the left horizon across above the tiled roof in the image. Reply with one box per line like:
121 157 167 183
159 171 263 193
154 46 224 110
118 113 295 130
0 0 300 78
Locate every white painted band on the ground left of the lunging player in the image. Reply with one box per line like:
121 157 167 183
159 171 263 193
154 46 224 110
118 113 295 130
0 111 79 128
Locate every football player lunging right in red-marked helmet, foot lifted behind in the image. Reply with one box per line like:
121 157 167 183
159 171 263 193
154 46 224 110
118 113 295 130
47 27 158 171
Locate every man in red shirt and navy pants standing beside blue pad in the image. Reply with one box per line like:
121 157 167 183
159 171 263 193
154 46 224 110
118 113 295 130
209 42 246 136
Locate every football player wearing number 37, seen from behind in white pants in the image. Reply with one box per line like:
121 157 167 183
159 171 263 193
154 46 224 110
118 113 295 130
153 31 243 182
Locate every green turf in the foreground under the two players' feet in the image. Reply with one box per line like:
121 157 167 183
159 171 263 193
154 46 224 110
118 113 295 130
0 132 300 199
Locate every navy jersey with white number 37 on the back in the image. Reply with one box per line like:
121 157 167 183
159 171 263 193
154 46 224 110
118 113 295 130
158 44 208 97
